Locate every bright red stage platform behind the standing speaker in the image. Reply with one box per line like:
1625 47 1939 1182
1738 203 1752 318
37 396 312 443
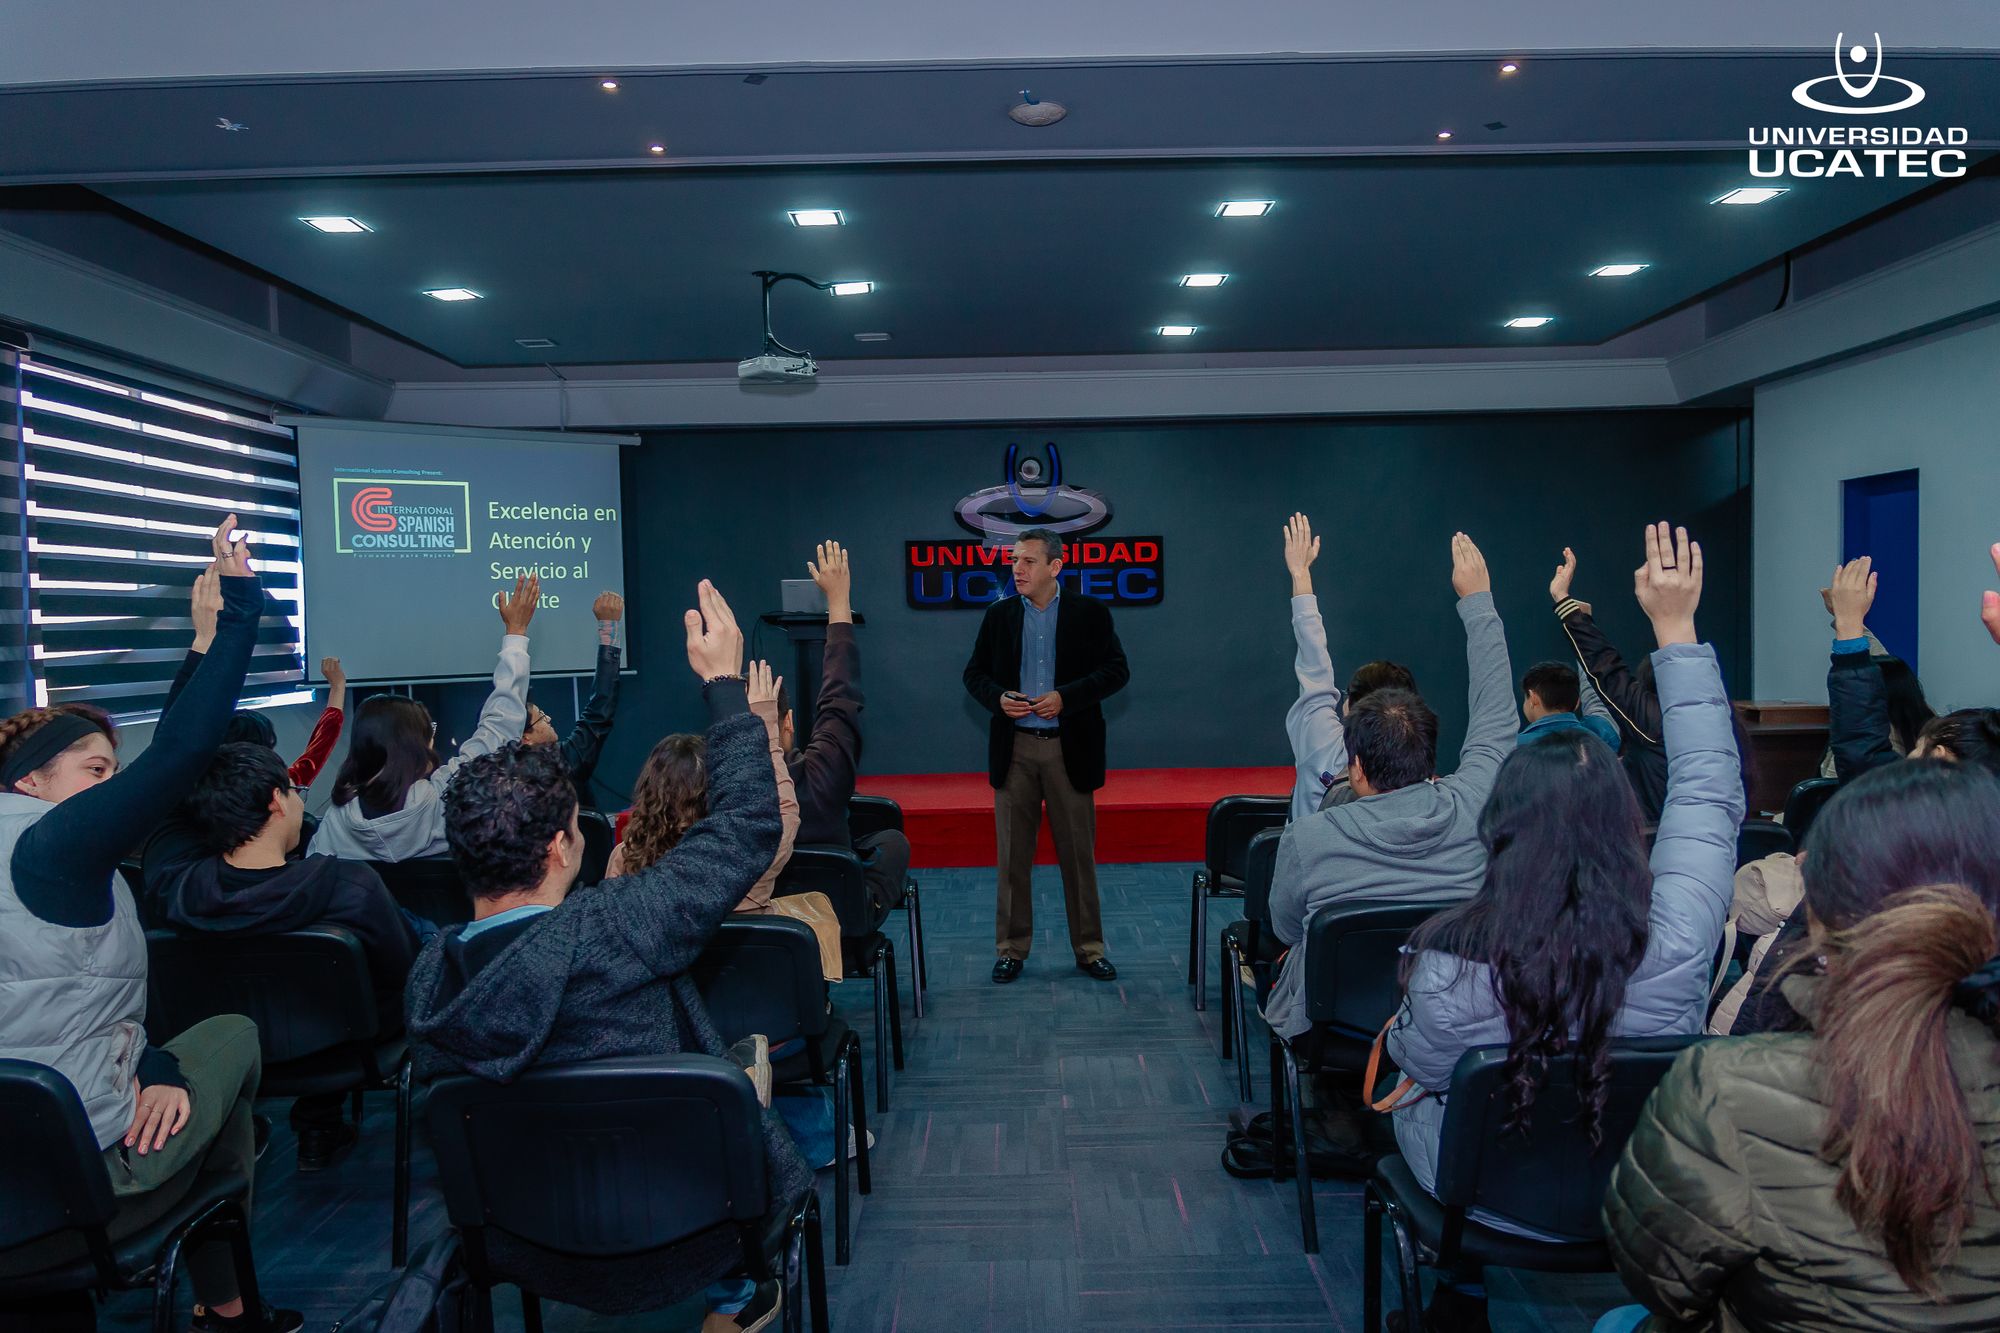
860 769 1292 867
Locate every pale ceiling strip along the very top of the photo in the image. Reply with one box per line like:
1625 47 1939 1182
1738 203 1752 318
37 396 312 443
11 0 2000 84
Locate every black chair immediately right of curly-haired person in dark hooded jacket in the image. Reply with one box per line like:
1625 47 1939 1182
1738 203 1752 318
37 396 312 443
692 915 872 1265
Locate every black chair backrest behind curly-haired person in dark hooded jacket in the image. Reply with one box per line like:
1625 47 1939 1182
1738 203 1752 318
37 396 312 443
430 1055 766 1256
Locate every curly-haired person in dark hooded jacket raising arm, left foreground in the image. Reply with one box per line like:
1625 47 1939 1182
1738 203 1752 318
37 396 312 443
408 580 812 1331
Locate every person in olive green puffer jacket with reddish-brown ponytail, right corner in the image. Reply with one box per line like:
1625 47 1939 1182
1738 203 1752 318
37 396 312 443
1598 761 2000 1333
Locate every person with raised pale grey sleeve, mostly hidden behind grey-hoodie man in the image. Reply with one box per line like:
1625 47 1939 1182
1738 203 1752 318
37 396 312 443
1284 514 1416 819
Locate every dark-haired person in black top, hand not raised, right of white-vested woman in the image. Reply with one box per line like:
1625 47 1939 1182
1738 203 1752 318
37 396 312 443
146 743 418 1171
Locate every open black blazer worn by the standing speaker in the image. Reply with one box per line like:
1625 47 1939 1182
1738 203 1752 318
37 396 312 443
966 588 1132 791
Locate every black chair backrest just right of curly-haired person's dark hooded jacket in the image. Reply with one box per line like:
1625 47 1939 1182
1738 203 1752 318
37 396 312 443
690 915 828 1047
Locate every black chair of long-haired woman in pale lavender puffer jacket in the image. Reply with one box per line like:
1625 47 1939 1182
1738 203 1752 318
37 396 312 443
1362 1035 1700 1333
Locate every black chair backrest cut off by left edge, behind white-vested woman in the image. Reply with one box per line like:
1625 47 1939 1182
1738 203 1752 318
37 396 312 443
0 1061 118 1249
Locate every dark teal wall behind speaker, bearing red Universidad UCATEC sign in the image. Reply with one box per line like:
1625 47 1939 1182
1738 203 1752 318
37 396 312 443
564 412 1750 791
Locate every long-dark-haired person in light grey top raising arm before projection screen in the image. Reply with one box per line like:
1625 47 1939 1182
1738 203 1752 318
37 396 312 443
308 576 542 861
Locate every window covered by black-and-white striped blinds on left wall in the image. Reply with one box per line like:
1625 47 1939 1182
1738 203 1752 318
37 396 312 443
0 354 306 719
